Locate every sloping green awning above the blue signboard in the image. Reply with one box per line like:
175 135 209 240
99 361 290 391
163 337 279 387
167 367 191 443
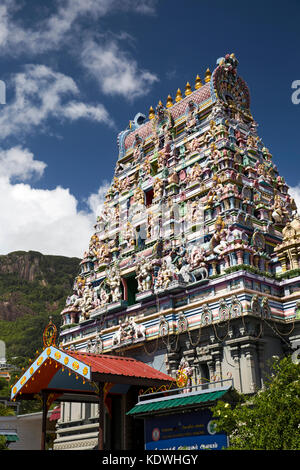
126 389 228 415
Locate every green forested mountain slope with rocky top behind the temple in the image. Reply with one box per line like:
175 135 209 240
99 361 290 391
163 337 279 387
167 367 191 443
0 251 80 367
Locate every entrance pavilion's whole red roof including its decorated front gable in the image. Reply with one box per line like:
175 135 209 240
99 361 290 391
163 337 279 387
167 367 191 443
11 346 174 400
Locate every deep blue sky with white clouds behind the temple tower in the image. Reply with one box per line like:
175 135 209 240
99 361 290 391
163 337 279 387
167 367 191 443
0 0 300 256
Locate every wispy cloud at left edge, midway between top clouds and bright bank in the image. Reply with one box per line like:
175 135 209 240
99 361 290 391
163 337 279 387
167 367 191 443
0 65 112 138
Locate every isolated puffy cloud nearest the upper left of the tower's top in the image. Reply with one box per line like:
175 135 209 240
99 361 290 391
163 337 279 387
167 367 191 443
81 40 158 99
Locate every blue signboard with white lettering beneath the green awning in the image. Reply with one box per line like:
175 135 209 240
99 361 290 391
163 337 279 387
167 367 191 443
145 409 228 450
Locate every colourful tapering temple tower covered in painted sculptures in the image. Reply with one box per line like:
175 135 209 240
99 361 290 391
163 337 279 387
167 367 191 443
55 54 300 449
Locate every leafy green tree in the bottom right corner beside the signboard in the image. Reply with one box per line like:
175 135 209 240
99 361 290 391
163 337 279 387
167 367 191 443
212 357 300 450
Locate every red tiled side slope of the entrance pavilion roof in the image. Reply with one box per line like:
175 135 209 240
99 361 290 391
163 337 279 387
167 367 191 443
68 350 174 382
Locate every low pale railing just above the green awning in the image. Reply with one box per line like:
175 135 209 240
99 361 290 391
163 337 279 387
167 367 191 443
138 378 233 402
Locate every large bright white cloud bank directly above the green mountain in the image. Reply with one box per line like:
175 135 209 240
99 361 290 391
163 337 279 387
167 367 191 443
0 147 107 258
